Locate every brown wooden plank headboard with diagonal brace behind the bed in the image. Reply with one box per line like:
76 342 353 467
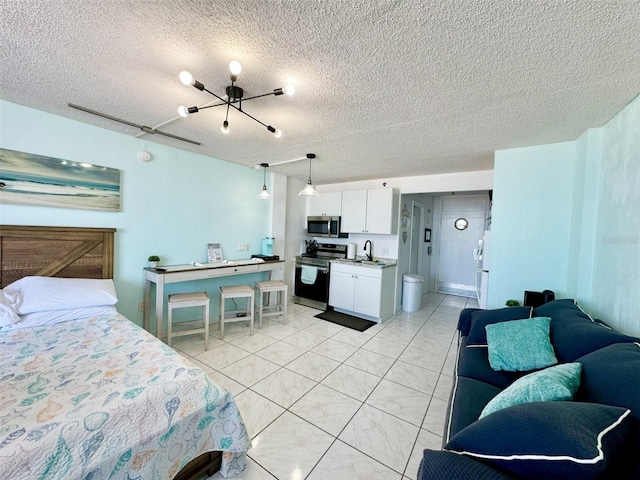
0 225 116 288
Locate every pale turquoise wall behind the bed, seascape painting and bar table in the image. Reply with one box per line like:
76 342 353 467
0 101 270 325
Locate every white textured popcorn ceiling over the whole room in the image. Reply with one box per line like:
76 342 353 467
0 0 640 183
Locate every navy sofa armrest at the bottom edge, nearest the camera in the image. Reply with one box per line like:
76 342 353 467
416 449 515 480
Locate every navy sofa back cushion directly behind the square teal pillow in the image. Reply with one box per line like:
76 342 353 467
533 299 640 362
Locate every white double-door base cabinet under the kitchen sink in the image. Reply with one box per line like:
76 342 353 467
329 262 396 321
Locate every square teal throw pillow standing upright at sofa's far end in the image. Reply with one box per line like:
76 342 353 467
486 317 558 372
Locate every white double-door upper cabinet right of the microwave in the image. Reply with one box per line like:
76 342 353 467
341 188 400 234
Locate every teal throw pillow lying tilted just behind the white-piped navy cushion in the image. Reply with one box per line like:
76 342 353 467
480 362 582 418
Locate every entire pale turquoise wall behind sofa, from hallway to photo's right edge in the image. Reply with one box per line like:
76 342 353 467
488 97 640 335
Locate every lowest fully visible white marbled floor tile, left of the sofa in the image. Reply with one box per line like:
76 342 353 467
338 405 420 473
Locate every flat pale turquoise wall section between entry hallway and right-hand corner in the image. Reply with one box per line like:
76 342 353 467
487 142 575 308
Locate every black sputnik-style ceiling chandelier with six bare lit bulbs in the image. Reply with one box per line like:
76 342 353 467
178 60 296 137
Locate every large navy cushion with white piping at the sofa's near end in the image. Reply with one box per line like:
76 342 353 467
445 402 630 480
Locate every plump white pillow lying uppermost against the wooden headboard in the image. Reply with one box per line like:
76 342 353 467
4 277 118 315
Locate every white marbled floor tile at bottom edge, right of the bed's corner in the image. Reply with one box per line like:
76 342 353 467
249 412 335 480
